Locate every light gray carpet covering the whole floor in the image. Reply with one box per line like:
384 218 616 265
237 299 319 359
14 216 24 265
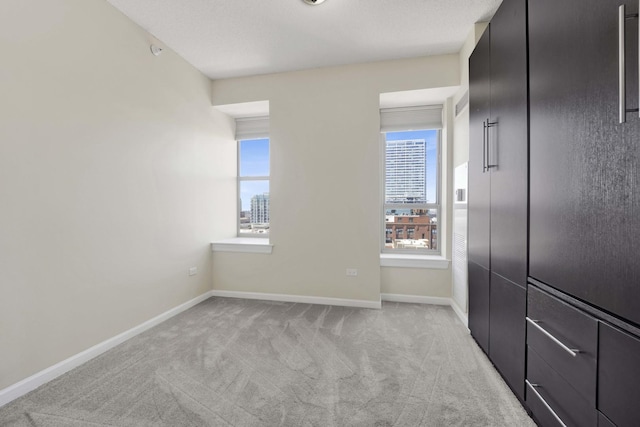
0 298 535 427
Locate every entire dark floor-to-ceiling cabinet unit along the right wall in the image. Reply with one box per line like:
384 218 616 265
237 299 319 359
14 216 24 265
468 0 640 427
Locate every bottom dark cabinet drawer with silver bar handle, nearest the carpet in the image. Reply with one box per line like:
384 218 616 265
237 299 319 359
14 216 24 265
527 348 598 427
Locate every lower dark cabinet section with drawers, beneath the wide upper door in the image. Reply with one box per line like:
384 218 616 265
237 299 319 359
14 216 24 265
526 284 640 427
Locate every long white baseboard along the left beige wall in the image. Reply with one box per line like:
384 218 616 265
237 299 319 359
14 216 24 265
0 291 212 407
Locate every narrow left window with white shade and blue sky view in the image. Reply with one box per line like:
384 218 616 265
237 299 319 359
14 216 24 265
236 118 271 237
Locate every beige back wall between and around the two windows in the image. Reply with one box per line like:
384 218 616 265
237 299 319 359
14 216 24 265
213 55 459 301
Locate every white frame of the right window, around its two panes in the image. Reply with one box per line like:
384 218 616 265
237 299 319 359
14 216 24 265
380 128 443 255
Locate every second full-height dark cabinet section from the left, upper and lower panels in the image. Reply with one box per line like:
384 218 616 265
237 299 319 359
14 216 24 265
487 0 528 400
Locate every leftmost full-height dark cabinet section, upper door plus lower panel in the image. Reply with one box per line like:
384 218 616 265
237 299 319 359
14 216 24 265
467 28 491 354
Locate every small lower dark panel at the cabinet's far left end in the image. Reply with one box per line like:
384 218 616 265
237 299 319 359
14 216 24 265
469 262 489 354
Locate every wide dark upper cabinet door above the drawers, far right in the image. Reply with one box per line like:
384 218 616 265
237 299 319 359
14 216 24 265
529 0 640 324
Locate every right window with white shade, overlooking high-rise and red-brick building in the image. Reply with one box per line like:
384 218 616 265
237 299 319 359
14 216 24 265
381 107 442 253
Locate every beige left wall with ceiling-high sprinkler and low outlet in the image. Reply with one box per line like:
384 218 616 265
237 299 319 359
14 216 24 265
0 0 235 389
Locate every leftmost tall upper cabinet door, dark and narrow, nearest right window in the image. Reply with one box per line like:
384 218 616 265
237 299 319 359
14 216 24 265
468 28 491 269
